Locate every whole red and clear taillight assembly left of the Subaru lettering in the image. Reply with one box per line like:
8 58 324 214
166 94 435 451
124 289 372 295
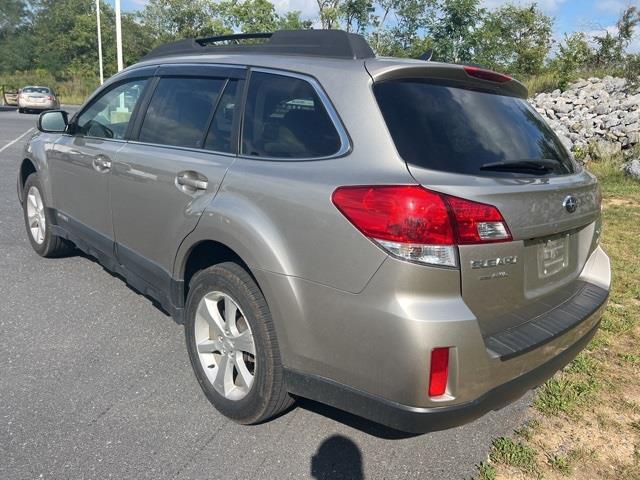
332 185 511 267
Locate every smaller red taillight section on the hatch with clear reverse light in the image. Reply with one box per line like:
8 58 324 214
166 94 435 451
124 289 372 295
446 195 511 245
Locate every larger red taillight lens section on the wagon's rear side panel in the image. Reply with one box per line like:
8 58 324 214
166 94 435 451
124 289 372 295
332 185 454 245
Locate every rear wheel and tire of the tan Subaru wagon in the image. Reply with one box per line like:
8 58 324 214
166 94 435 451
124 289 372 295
185 262 293 425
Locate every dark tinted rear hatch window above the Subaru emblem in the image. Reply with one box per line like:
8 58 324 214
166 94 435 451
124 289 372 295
373 79 573 176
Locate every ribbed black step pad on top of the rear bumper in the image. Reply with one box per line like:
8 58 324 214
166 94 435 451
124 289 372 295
484 282 609 360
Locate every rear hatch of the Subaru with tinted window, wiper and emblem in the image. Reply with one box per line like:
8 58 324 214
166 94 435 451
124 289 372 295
367 60 601 343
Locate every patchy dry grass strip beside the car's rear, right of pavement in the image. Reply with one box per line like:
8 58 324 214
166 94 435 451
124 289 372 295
478 156 640 480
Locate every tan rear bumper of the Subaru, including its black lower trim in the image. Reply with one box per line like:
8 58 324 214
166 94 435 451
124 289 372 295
264 247 611 432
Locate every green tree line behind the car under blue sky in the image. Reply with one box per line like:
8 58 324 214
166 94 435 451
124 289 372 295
0 0 640 96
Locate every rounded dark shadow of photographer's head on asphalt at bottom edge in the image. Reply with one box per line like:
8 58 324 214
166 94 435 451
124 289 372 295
311 435 364 480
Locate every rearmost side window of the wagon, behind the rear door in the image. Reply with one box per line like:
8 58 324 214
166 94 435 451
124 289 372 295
242 72 341 158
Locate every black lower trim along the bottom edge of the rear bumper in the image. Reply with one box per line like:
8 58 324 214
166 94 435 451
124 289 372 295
285 321 600 433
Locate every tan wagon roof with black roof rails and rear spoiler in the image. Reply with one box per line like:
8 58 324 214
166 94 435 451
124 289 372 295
125 30 527 98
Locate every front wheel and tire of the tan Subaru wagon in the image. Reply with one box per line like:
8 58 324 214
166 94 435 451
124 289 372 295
22 173 72 258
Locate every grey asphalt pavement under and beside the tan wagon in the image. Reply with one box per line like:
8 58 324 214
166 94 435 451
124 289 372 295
0 106 530 480
